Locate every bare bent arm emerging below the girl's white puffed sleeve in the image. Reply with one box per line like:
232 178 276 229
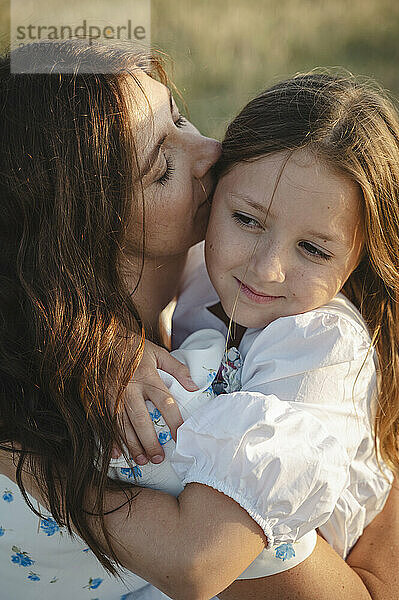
97 483 267 600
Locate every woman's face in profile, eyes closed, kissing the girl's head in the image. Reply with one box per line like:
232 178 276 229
128 71 220 258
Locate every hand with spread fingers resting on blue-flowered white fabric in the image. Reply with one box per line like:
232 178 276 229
113 340 198 465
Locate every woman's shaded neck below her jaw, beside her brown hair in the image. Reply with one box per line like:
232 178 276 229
126 253 187 343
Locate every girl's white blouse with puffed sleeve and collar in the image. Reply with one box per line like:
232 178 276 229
173 245 392 558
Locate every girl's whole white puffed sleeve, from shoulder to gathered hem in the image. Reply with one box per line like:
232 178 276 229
172 311 375 548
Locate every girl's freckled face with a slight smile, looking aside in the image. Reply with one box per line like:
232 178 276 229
206 149 363 328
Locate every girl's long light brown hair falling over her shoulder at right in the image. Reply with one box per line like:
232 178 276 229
215 71 399 472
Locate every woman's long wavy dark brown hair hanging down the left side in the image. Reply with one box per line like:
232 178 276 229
0 41 170 573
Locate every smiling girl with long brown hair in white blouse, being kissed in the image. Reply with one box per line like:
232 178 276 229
113 73 399 578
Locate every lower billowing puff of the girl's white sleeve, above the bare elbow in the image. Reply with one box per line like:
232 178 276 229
172 392 349 547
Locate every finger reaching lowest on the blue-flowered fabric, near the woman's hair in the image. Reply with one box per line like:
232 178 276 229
124 381 165 464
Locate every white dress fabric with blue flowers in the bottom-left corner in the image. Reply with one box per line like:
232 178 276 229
0 475 153 600
